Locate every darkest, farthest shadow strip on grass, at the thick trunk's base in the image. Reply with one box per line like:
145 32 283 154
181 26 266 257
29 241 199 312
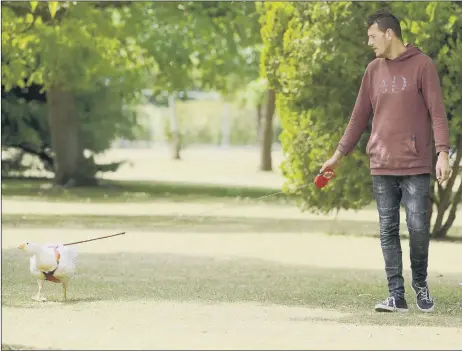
2 178 290 202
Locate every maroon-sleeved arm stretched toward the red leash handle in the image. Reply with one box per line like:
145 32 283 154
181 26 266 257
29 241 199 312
336 69 372 155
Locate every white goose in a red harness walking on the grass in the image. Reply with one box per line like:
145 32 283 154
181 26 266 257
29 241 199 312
18 242 77 301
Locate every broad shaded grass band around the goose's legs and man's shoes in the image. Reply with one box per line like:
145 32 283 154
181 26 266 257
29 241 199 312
2 250 462 326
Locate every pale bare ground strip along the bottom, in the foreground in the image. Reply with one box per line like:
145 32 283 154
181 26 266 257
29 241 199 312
2 301 462 350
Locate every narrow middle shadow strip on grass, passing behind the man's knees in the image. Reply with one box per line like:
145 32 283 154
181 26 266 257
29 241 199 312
2 214 462 243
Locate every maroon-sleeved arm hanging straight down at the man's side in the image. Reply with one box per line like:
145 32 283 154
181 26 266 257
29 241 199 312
422 60 449 154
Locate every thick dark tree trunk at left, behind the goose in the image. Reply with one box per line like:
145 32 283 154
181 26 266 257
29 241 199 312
47 87 96 186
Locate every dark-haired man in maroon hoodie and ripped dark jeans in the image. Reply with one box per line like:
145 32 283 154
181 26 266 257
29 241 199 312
320 11 450 312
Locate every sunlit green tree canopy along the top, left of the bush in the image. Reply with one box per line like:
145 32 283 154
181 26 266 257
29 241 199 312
2 1 261 103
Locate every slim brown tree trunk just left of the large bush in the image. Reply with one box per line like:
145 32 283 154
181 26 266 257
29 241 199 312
260 89 276 171
